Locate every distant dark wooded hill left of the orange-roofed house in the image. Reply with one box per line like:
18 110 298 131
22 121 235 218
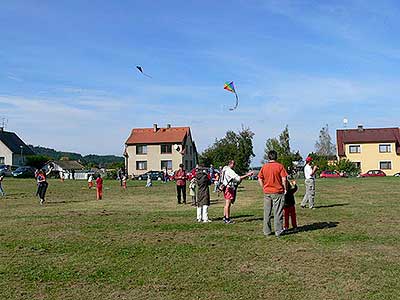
29 145 124 167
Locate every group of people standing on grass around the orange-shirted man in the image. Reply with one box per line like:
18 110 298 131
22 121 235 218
175 150 317 237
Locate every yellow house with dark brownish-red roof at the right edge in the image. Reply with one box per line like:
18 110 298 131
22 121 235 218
336 125 400 175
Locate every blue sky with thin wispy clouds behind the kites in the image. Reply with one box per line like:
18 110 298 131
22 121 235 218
0 0 400 165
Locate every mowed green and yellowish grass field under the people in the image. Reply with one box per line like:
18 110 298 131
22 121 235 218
0 177 400 299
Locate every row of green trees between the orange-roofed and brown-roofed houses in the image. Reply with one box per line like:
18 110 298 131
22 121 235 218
199 125 359 174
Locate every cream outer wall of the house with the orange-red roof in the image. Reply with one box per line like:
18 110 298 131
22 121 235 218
125 136 196 176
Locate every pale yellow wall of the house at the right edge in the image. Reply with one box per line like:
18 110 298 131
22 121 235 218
345 143 400 175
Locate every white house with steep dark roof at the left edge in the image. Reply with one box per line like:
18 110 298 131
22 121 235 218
0 127 35 166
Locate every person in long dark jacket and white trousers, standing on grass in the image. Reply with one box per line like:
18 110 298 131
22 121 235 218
196 169 211 223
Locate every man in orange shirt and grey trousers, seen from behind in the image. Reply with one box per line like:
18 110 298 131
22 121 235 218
258 150 287 237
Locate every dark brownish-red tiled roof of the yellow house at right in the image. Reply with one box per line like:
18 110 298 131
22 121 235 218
336 127 400 156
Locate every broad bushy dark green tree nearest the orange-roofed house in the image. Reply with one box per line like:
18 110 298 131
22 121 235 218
199 128 254 173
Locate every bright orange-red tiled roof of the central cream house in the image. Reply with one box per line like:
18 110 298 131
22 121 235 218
125 127 190 145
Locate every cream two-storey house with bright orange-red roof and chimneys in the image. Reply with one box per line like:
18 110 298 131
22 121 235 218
124 124 197 176
